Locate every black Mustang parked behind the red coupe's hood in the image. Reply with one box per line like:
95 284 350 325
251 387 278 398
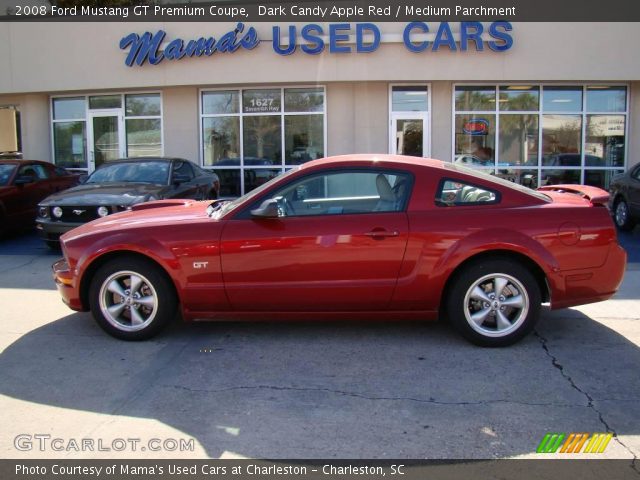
36 157 220 247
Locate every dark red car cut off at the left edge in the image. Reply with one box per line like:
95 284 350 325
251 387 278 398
0 160 79 234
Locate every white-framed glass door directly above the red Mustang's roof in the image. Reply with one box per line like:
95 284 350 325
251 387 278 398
389 112 429 157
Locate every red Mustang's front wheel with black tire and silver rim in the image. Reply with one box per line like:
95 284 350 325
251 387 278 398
89 257 178 340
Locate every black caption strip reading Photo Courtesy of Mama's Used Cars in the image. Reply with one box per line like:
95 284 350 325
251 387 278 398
0 459 640 480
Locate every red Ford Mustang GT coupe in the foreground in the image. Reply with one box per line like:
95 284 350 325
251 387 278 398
53 155 626 346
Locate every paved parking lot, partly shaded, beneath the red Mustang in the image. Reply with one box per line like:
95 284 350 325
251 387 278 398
0 228 640 460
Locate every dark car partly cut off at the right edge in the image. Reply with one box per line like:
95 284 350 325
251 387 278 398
609 163 640 230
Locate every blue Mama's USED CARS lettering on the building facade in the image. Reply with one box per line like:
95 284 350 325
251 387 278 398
120 21 513 67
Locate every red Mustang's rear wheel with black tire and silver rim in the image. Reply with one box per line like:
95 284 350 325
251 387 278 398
445 259 542 347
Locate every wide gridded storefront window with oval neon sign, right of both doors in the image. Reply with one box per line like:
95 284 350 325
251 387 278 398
454 85 628 189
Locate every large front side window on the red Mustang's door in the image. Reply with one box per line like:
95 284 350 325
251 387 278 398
258 170 411 216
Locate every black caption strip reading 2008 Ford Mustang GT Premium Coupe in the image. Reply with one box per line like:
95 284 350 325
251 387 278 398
0 0 640 21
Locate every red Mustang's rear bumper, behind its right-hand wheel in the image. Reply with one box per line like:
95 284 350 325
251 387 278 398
551 243 627 310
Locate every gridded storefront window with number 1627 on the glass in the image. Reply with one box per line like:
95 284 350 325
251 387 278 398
201 87 326 197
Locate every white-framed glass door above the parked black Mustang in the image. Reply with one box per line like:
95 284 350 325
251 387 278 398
89 110 126 172
